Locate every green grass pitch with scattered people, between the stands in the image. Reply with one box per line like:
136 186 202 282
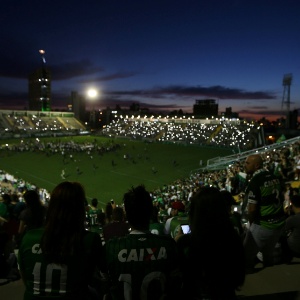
0 136 231 207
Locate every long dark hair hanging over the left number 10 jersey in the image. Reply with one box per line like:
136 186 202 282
41 181 85 264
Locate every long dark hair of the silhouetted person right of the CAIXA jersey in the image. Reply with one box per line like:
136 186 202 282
189 187 245 293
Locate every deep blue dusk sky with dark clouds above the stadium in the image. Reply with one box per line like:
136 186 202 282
0 0 300 119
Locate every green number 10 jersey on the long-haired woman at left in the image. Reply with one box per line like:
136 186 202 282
18 228 104 300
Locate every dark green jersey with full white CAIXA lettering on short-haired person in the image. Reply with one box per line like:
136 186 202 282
105 231 178 300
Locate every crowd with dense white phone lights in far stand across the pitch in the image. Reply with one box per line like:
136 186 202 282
101 118 260 150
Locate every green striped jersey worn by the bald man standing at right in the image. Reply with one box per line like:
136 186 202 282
246 169 285 229
